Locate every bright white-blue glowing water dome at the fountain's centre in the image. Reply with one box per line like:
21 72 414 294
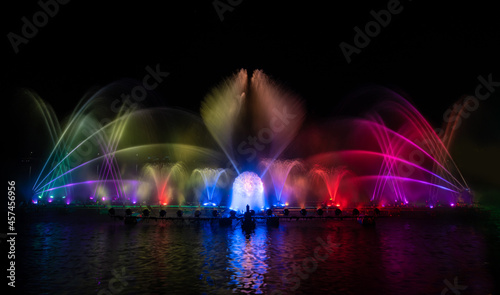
231 171 264 211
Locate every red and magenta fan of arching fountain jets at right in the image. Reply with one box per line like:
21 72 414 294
302 89 470 206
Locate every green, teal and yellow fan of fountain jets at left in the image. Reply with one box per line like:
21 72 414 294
29 83 223 205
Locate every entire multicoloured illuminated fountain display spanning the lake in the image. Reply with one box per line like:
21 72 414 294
20 70 472 212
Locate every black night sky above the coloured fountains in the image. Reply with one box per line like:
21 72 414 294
2 0 500 192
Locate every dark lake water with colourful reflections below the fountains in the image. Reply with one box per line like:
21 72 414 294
16 209 499 294
